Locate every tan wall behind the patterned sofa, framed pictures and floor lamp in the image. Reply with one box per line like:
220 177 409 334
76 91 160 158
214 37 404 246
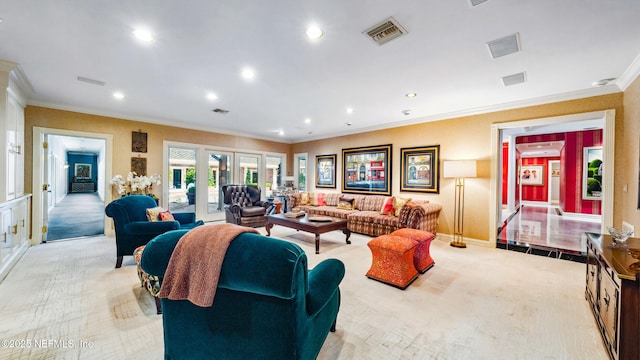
293 93 624 241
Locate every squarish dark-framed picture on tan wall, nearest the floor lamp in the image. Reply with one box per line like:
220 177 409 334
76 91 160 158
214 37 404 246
400 145 440 194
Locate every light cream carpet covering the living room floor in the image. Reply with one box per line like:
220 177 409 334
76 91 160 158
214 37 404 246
0 226 608 360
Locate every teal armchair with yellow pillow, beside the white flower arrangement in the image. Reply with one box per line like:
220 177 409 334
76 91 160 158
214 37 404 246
105 195 204 268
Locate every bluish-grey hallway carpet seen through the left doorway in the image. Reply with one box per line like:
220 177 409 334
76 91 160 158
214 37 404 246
47 192 104 241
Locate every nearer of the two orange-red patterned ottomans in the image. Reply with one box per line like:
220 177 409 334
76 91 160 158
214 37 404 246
367 235 419 290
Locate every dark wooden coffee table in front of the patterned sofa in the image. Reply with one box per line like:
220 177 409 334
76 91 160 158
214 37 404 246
265 214 351 254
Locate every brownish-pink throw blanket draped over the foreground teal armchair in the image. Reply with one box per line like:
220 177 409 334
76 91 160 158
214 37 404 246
158 224 258 307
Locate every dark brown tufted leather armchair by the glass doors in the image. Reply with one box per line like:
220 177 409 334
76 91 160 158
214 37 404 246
222 185 275 227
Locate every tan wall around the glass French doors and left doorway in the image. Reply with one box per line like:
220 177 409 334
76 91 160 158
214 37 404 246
24 106 292 197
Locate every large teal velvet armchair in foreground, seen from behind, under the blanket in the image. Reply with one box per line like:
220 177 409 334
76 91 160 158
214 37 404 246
141 231 345 360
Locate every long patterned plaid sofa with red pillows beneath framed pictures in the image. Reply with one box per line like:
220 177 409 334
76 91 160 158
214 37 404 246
287 192 442 236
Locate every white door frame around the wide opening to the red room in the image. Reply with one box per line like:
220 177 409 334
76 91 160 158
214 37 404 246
489 109 616 247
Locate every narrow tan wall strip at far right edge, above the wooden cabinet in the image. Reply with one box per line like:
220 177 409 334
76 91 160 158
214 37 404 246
614 77 640 232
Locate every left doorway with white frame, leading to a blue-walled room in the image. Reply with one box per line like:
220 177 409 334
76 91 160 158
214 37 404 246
32 127 112 245
